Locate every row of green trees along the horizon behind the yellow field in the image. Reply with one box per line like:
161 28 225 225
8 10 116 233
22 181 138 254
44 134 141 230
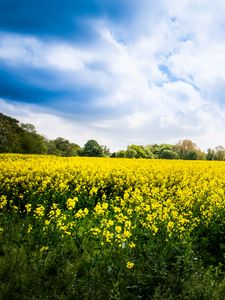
0 113 225 160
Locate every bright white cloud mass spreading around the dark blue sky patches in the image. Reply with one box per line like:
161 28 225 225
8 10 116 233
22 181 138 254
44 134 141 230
0 0 225 149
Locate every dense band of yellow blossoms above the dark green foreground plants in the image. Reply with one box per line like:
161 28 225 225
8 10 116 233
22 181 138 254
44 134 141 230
0 155 225 241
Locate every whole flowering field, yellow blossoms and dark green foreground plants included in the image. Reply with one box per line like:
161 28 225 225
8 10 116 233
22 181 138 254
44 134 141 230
0 154 225 299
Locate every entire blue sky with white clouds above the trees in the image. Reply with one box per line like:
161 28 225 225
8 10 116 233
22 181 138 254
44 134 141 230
0 0 225 151
